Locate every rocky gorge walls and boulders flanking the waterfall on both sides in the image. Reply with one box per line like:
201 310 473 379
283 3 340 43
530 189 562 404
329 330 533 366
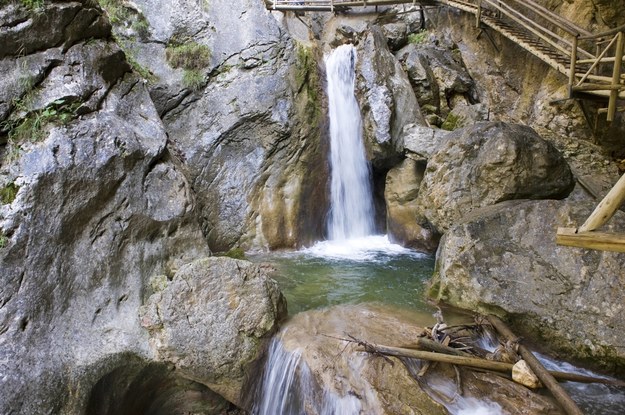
0 0 625 414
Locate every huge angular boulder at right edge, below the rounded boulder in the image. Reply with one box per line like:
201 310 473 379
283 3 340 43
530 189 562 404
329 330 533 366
430 200 625 369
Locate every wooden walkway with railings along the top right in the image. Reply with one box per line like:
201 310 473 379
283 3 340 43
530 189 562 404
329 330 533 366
265 0 625 121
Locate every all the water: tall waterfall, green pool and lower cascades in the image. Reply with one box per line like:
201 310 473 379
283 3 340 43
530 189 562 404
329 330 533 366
250 45 625 415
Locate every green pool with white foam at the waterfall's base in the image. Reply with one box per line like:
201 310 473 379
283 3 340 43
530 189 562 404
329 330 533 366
250 235 434 315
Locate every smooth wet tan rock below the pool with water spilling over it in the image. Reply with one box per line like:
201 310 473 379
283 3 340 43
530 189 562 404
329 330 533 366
254 305 559 415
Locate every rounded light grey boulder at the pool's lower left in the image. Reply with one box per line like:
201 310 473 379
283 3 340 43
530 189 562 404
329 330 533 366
140 257 286 406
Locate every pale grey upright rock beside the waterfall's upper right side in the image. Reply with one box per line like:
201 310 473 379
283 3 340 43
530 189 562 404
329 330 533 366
357 26 424 167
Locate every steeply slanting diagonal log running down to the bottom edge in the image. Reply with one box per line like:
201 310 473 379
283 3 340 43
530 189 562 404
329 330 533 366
487 315 584 415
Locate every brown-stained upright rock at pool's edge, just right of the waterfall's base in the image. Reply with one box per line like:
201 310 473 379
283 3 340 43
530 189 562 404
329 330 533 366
384 158 439 252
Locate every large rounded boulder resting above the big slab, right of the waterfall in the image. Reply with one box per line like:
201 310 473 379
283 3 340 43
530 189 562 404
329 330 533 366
418 123 574 233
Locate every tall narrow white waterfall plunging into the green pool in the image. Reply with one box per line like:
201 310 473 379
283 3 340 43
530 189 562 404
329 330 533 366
325 45 374 240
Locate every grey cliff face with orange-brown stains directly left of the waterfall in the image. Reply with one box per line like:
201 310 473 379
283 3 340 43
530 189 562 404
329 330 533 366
109 0 327 251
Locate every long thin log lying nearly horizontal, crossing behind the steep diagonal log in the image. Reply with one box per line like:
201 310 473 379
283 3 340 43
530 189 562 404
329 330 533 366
356 343 625 386
